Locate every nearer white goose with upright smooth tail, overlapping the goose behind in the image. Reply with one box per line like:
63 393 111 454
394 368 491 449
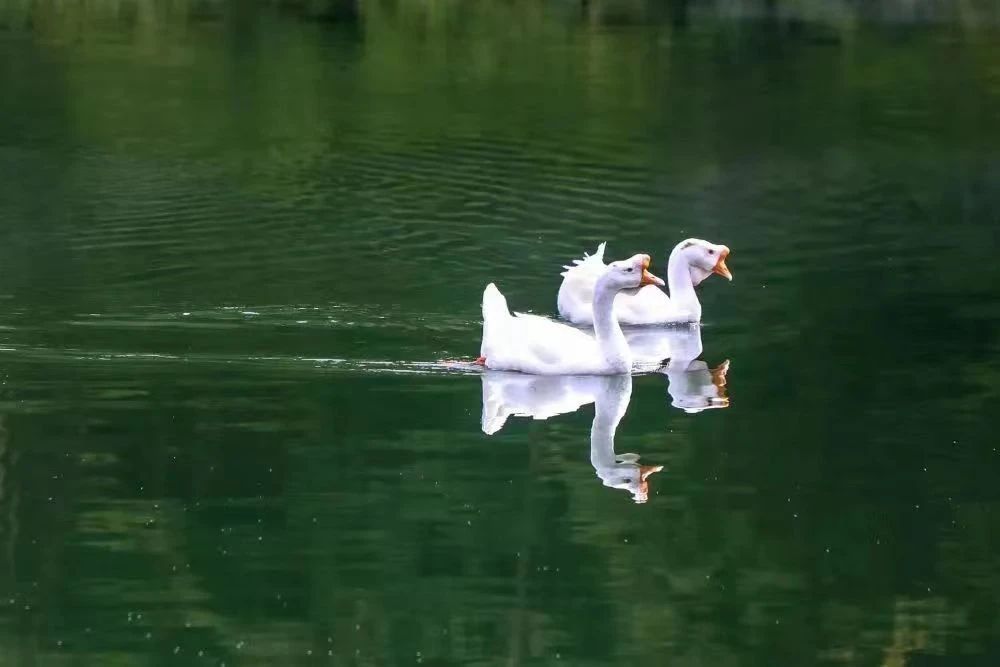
478 255 663 375
